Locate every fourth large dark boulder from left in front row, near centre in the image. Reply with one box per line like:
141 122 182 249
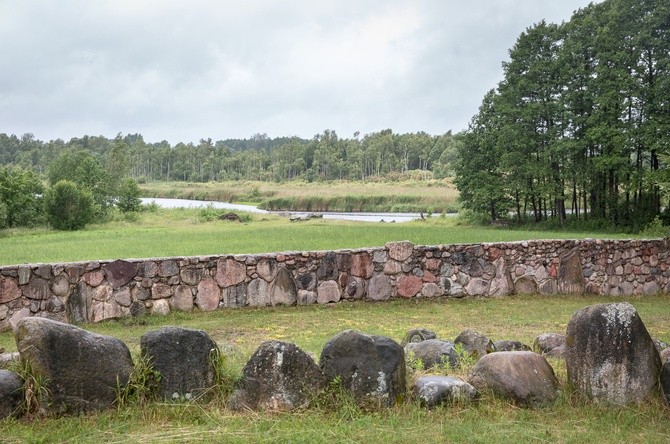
319 330 406 406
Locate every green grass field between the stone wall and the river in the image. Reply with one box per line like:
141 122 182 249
0 209 644 265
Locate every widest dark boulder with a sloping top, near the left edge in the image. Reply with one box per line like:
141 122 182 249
15 317 133 413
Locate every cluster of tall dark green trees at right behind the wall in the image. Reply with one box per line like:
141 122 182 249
455 0 670 227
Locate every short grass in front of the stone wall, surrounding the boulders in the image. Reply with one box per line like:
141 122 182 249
0 295 670 443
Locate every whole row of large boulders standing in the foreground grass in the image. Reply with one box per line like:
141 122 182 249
0 302 670 418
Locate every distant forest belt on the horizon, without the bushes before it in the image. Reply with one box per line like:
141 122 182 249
0 129 458 182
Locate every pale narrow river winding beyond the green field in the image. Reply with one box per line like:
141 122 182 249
142 197 434 222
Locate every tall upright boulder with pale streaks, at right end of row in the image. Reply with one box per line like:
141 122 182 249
565 302 661 404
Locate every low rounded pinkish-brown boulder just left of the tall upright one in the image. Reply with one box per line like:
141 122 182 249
468 351 559 407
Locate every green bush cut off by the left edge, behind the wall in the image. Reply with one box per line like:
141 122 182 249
0 166 44 228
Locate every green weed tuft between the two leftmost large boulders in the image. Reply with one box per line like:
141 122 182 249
116 355 161 408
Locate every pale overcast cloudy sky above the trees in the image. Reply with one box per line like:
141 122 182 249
0 0 600 144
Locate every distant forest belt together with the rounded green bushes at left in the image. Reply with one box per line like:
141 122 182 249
0 130 458 230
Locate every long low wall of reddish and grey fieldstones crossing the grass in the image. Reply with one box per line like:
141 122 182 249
0 239 670 329
